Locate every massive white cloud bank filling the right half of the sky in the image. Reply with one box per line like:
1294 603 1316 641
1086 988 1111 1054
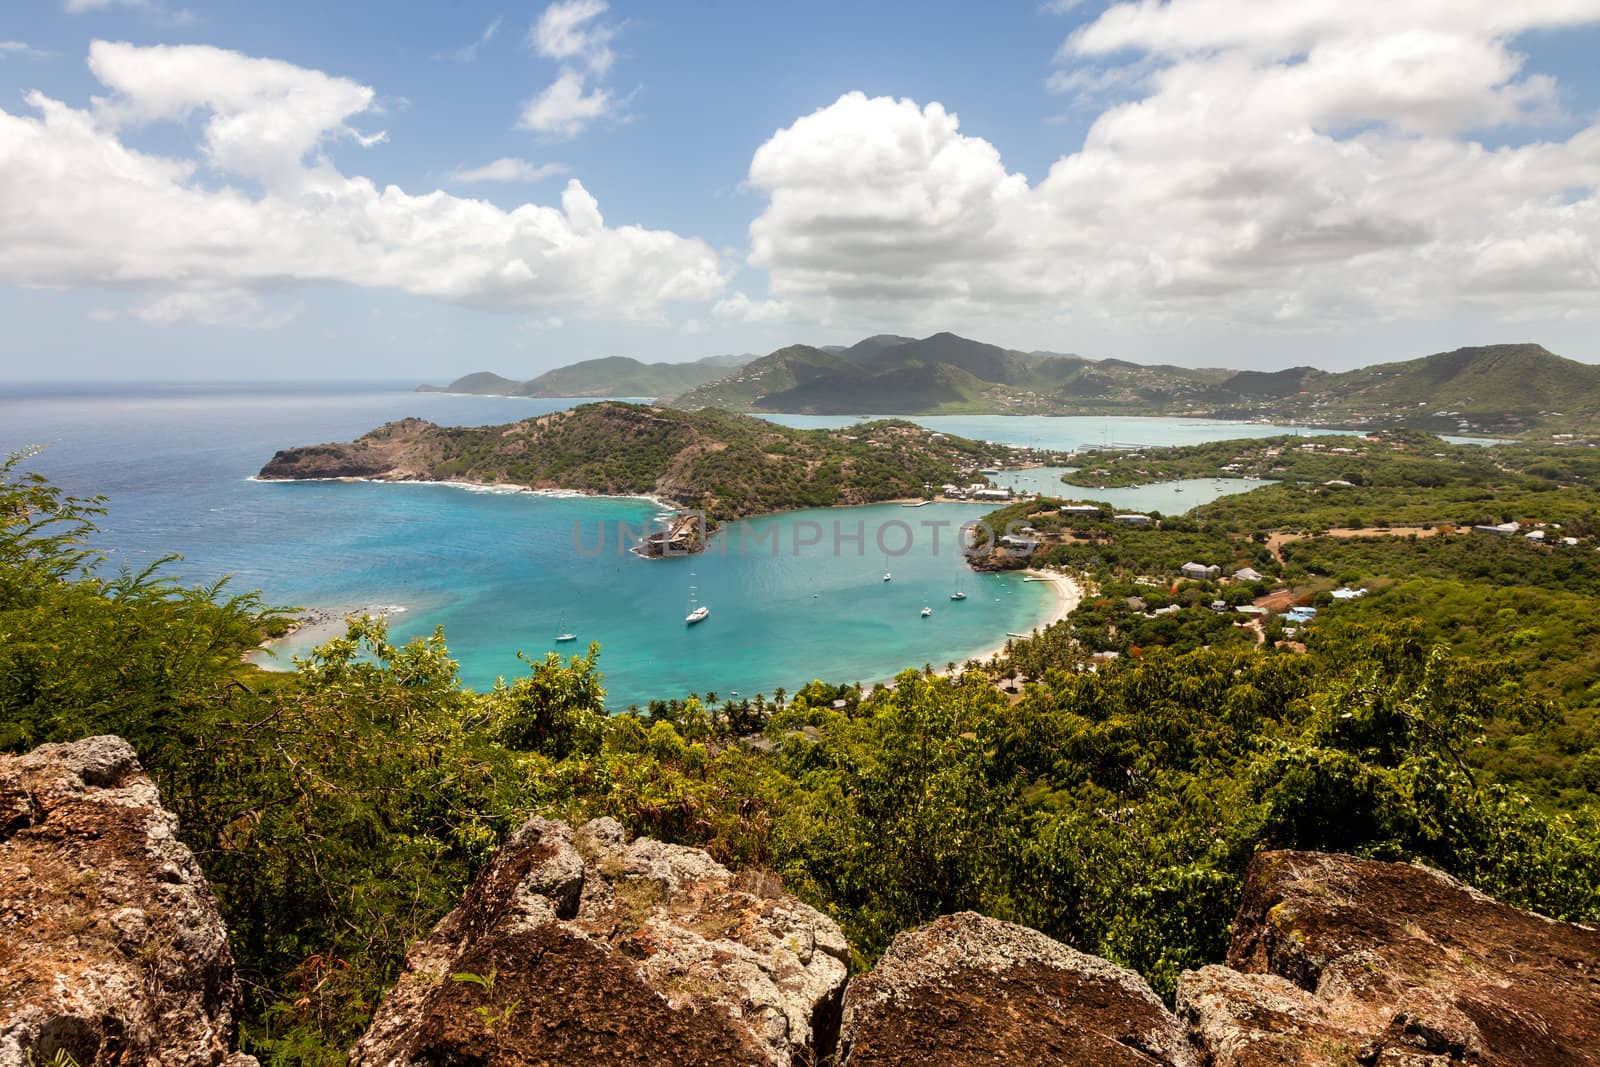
730 0 1600 326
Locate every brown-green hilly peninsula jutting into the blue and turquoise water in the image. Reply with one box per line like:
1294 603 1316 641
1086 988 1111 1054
259 402 1034 522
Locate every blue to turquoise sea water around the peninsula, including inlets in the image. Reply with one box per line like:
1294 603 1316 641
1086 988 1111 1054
0 382 1337 707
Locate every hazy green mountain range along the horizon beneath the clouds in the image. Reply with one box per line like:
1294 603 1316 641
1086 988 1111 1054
428 333 1600 434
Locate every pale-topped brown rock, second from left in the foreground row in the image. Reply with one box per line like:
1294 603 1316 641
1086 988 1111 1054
352 819 850 1067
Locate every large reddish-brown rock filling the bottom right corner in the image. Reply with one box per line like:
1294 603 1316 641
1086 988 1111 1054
1178 853 1600 1067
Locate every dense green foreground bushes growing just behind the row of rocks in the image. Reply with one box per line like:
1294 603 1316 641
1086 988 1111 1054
9 462 1600 1064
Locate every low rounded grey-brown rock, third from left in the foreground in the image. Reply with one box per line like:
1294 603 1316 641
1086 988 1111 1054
840 912 1197 1067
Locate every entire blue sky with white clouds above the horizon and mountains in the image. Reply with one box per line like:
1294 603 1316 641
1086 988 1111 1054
0 0 1600 382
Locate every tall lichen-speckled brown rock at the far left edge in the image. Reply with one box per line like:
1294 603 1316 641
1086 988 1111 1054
0 737 254 1067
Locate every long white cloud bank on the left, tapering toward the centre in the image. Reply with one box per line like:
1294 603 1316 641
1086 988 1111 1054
0 42 723 322
